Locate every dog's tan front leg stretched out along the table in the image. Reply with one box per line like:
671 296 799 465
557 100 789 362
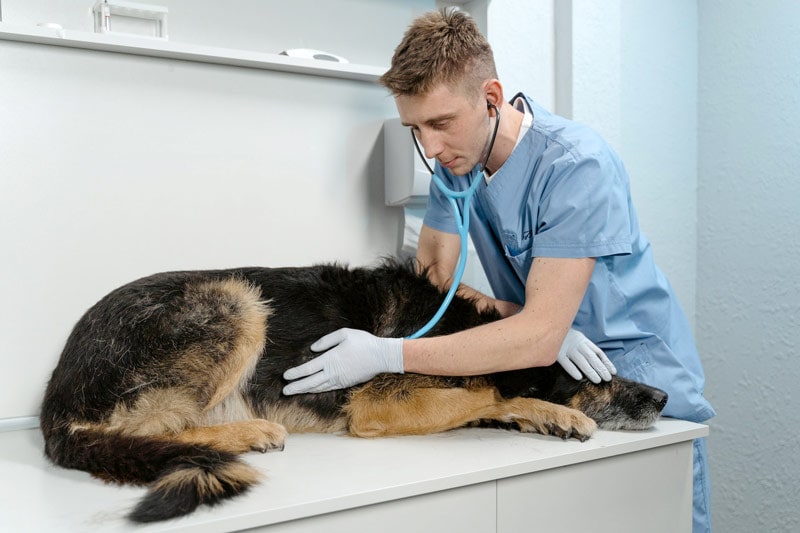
345 382 597 441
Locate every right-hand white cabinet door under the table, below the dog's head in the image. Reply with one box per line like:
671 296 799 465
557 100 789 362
497 441 692 533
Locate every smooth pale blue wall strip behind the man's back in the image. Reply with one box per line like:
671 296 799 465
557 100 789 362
620 0 698 320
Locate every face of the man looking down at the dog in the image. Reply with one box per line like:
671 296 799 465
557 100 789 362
395 84 490 176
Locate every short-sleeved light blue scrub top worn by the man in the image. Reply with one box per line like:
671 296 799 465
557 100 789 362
424 95 715 422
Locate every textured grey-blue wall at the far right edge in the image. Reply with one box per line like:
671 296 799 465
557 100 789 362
697 0 800 533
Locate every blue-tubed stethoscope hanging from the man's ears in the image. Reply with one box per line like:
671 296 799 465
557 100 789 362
406 101 500 339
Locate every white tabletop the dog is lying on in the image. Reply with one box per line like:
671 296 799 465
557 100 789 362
0 418 708 532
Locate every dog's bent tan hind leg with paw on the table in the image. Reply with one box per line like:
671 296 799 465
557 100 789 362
95 278 286 454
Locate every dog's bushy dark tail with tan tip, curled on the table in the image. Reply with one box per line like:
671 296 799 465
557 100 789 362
45 429 260 522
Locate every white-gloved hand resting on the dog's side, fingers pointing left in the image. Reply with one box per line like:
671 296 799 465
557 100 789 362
283 328 403 394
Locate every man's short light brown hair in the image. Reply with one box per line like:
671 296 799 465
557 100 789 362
379 8 497 96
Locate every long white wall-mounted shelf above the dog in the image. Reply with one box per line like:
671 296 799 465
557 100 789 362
0 22 386 82
